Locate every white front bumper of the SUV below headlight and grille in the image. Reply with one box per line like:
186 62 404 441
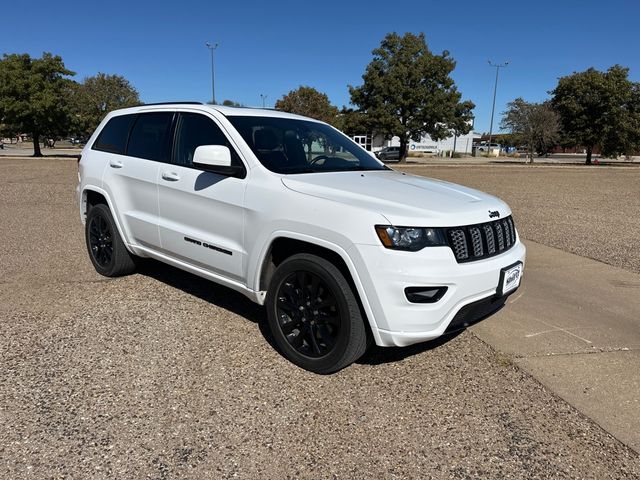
349 239 526 346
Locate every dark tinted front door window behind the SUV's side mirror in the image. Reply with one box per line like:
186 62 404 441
173 113 242 167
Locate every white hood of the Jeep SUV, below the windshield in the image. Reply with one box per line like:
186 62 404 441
282 170 511 227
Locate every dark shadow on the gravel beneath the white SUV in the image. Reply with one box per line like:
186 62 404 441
137 259 462 365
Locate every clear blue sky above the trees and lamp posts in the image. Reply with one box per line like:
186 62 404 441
0 0 640 131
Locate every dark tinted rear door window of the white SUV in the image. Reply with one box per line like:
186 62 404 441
127 112 173 162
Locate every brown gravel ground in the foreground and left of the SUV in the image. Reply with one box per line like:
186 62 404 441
0 159 640 479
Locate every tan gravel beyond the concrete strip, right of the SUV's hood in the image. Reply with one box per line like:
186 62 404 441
400 165 640 273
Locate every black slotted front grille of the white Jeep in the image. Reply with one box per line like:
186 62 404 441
445 216 516 263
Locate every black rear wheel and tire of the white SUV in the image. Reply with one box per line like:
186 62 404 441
85 203 136 277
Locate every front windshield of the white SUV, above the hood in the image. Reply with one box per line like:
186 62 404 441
227 116 387 173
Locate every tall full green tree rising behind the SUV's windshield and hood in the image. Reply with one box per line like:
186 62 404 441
349 33 474 161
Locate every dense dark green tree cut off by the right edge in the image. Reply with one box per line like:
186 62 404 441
550 65 640 165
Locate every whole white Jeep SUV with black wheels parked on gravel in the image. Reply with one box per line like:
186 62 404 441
78 103 525 373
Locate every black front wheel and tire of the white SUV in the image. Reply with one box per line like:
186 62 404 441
265 254 368 374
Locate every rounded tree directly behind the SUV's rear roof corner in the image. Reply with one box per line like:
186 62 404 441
72 73 140 136
